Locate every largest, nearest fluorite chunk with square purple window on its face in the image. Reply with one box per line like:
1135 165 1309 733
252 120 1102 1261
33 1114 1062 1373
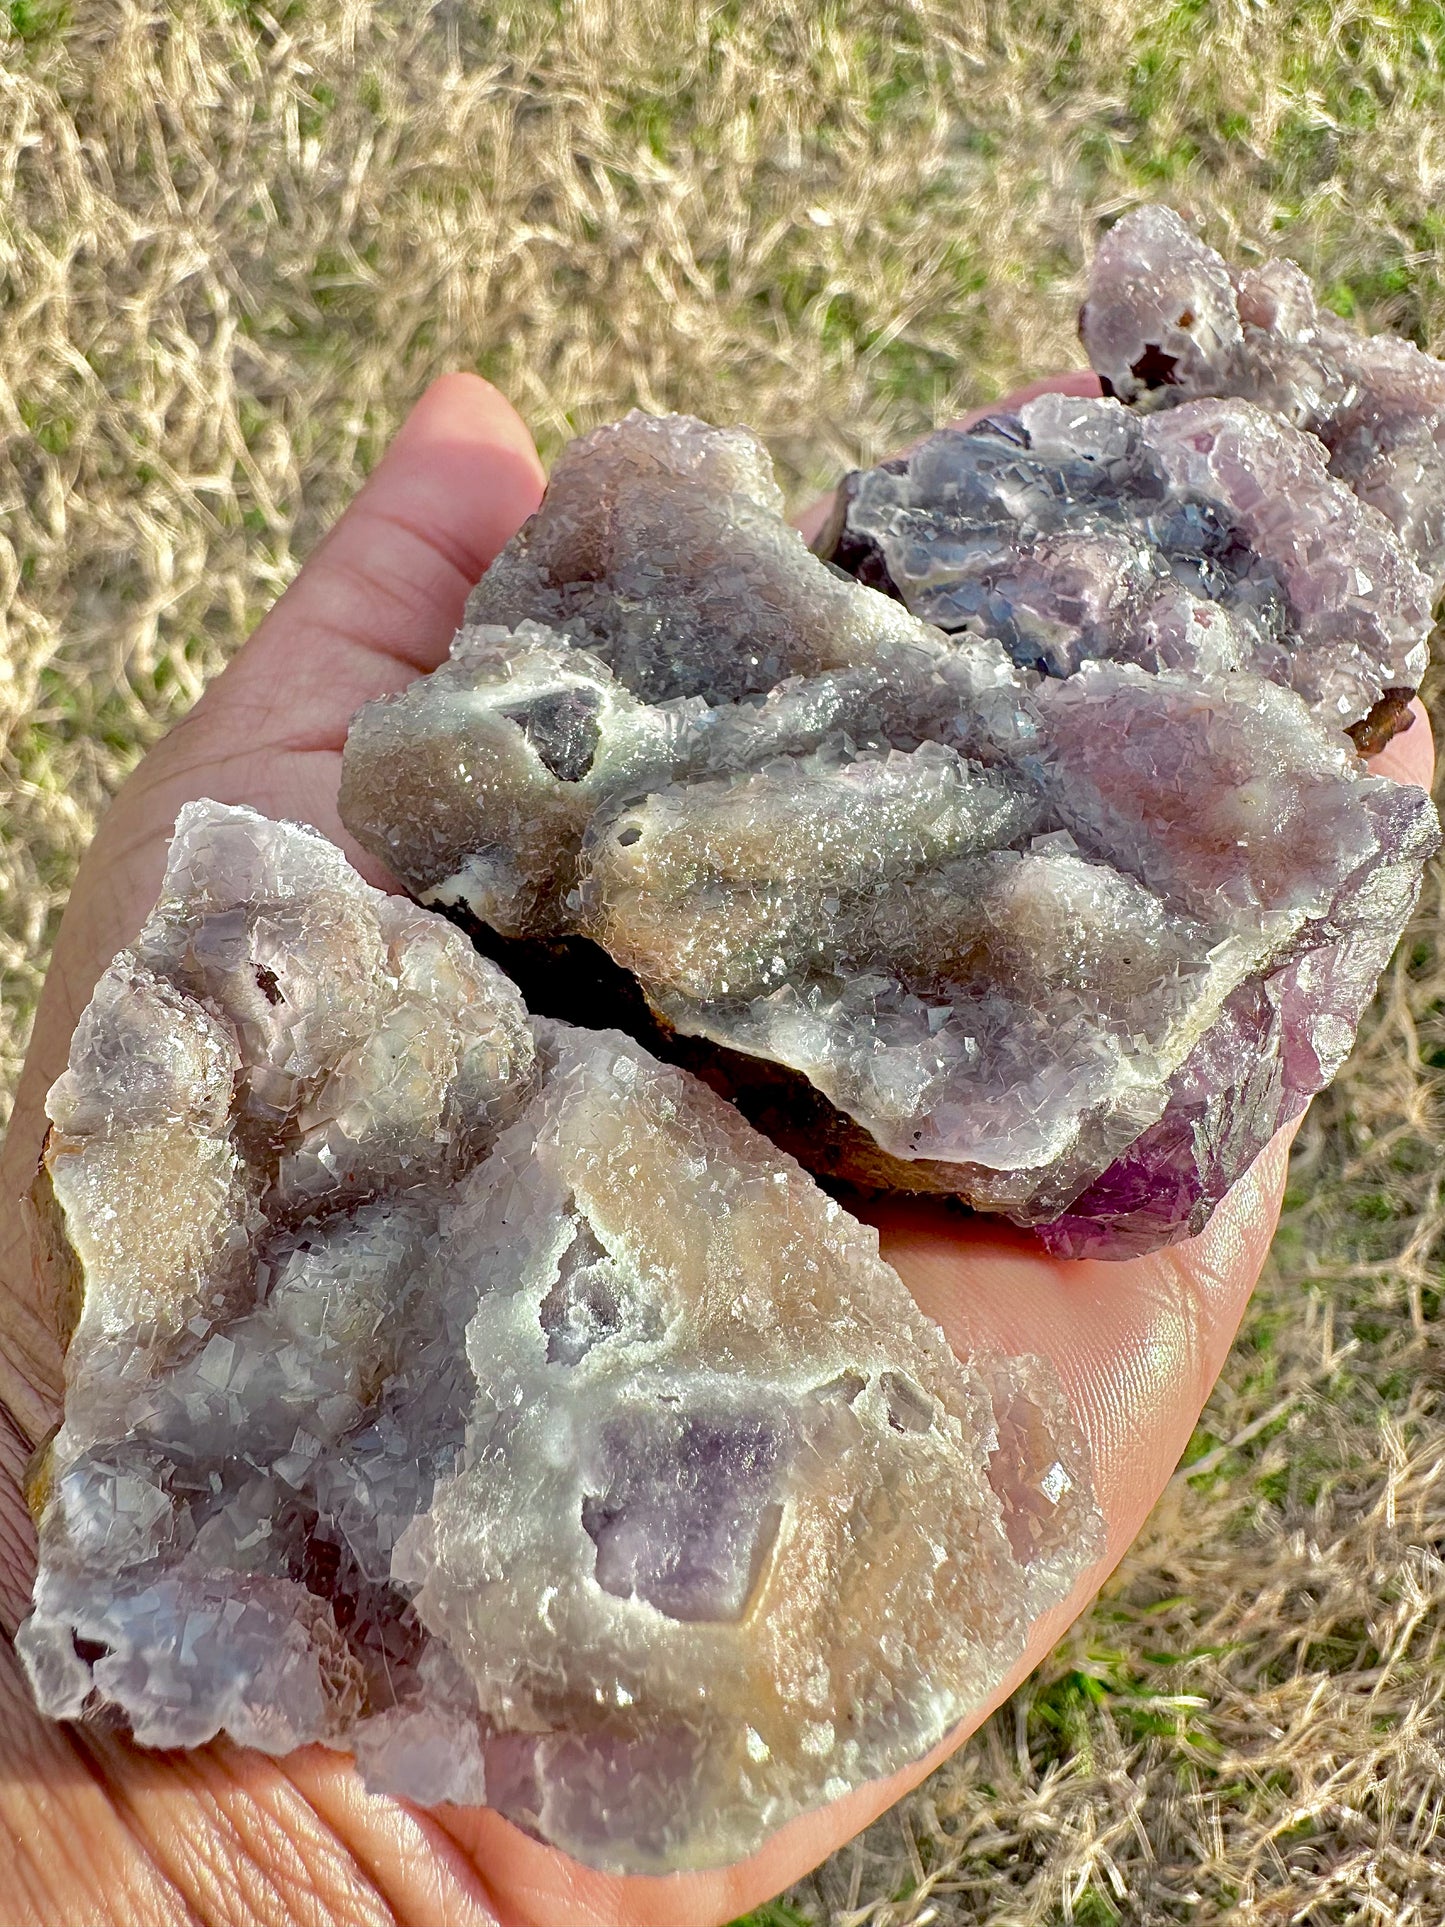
19 805 1102 1871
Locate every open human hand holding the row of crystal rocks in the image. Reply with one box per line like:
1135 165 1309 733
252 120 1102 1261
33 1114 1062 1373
0 376 1432 1927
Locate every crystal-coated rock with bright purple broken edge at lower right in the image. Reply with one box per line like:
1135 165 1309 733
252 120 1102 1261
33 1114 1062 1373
341 403 1437 1256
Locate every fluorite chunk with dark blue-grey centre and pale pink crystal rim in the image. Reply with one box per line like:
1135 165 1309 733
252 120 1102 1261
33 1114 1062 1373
823 383 1432 730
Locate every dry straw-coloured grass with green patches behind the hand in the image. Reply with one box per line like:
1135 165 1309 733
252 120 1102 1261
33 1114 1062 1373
0 0 1445 1927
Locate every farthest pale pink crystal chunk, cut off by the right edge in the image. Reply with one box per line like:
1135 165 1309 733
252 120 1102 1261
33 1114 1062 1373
1081 208 1445 590
